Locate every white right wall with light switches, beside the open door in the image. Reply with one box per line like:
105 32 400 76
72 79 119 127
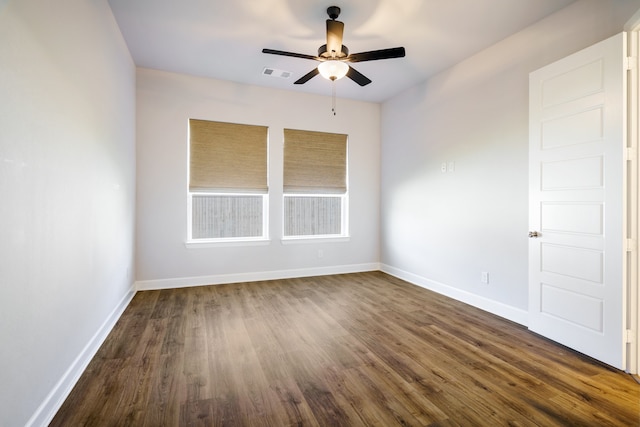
381 0 640 323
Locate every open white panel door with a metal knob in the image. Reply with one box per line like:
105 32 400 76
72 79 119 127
529 34 626 369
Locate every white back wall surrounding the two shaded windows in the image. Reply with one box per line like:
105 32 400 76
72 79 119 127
136 69 380 289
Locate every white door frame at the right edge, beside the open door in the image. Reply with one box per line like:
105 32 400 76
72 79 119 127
624 10 640 375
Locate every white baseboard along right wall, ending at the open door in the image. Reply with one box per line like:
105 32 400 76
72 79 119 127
380 264 529 326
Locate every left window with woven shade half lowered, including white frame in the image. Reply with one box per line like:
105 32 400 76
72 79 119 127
189 119 268 241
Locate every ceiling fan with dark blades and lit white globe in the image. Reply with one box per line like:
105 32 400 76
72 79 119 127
262 6 405 86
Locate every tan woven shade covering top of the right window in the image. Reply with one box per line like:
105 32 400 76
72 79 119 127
284 129 347 194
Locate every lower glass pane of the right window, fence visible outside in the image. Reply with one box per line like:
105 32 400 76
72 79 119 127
284 196 343 236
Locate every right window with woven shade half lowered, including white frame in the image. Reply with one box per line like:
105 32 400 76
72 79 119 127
283 129 348 238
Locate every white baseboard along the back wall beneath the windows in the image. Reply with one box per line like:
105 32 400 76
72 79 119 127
135 263 380 291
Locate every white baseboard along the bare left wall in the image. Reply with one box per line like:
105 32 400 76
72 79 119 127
25 288 136 427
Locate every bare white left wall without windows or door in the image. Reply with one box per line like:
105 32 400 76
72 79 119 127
0 0 135 427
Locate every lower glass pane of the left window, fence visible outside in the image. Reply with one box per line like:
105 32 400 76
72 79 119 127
191 194 263 239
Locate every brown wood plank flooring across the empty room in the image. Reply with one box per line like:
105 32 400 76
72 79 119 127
51 272 640 427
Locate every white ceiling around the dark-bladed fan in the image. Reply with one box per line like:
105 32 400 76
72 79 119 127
109 0 575 102
